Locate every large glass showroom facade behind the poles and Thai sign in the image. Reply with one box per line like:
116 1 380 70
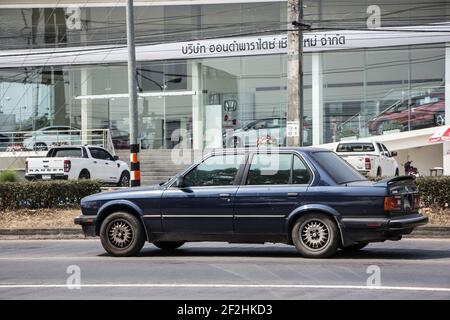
0 0 450 149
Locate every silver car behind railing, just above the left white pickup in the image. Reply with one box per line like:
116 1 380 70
23 126 81 151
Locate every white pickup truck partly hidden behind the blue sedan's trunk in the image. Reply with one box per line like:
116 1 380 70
334 141 399 177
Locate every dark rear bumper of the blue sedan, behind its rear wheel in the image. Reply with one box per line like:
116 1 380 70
341 214 428 245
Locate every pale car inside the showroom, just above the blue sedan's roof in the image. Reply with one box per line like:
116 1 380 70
223 118 311 148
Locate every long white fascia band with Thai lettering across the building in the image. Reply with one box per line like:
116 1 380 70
0 24 450 68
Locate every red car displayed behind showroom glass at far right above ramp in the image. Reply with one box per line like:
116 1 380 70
368 92 445 134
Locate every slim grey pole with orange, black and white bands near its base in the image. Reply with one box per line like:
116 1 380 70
126 0 141 187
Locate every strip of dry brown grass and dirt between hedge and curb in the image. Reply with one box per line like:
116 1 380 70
0 208 450 229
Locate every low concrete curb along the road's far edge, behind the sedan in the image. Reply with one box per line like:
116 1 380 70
0 225 450 240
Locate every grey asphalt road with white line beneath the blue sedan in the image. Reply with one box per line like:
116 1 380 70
0 239 450 300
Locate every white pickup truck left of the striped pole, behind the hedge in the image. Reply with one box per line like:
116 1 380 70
25 146 130 187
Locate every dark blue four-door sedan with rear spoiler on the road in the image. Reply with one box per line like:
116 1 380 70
74 148 428 258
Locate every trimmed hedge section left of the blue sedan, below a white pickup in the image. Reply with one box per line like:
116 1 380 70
0 180 101 210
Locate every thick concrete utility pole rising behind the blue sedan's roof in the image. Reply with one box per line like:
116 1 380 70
286 0 305 147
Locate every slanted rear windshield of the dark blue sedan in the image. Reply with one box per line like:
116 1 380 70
312 151 367 184
